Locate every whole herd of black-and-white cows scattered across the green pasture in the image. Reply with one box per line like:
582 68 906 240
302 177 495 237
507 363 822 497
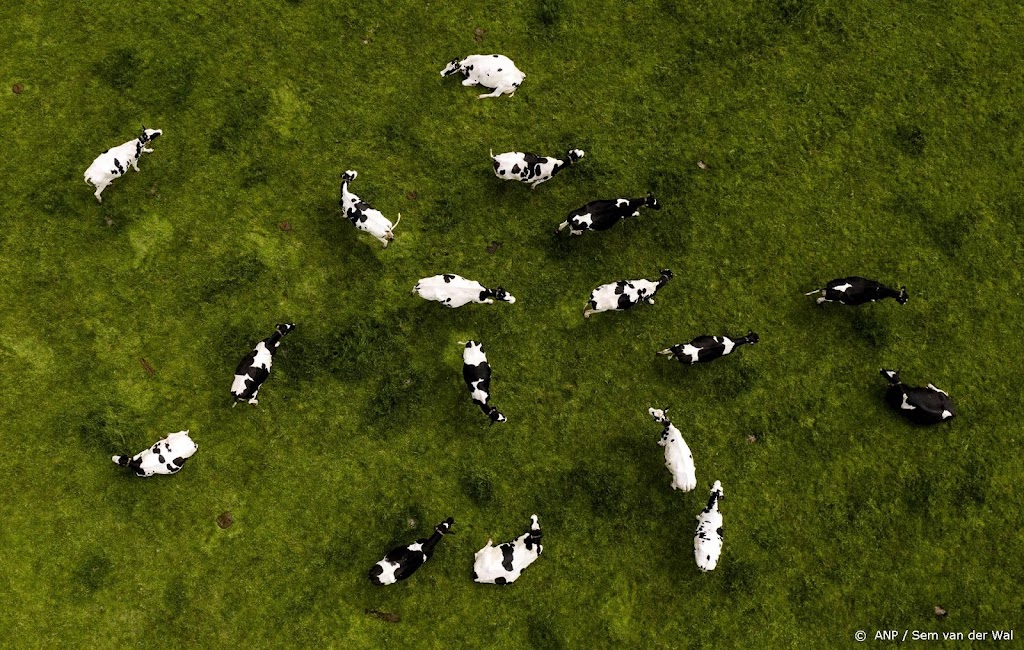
85 54 955 584
